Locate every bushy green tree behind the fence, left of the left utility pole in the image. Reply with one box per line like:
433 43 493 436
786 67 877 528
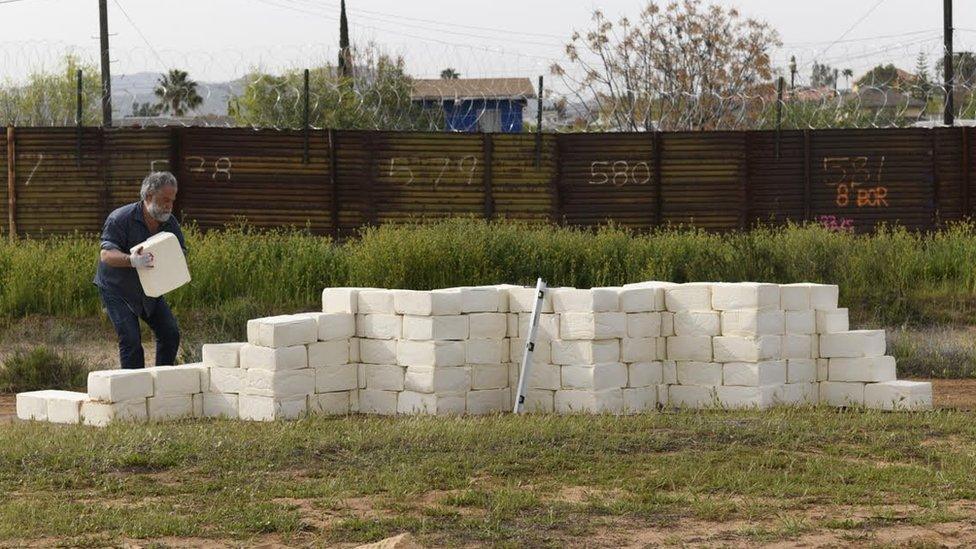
0 54 102 126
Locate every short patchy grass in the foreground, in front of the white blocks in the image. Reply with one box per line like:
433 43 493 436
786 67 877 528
0 409 976 547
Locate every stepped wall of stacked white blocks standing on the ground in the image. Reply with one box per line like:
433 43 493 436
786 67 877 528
17 282 932 426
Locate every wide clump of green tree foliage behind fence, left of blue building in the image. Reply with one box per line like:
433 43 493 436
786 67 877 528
228 44 443 130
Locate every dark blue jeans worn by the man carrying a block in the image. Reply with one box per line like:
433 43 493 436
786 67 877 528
98 288 180 368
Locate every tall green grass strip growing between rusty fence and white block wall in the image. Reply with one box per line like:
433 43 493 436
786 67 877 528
0 219 976 325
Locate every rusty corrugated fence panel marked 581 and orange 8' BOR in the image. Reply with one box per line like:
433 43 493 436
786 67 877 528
810 129 935 231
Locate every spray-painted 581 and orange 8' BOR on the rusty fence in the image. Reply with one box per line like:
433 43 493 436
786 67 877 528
823 156 888 208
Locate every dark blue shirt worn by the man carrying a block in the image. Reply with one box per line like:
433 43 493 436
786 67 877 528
93 201 186 315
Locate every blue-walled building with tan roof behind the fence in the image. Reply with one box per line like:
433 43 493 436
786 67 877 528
410 78 536 133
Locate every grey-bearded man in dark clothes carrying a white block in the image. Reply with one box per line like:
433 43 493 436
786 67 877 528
94 172 186 368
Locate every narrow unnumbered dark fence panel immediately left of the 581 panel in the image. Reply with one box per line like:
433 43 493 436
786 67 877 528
748 131 805 225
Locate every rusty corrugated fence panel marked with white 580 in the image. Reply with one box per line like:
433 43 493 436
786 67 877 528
557 133 657 228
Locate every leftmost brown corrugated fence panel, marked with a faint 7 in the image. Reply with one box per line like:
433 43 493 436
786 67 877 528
11 128 107 236
